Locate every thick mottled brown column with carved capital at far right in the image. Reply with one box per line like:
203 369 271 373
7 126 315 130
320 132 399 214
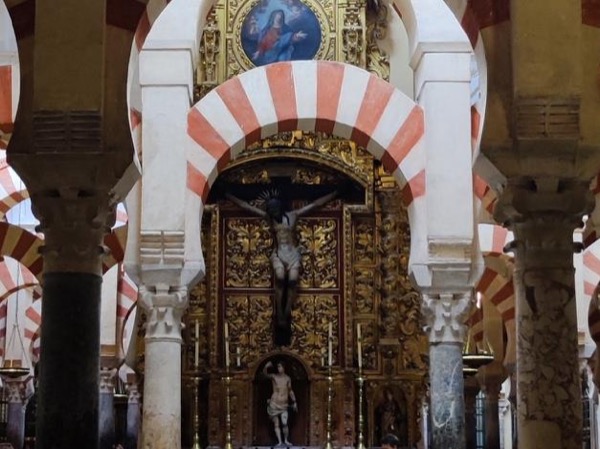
495 179 593 449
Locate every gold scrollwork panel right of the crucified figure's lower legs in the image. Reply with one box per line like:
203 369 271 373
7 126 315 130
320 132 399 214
290 295 339 366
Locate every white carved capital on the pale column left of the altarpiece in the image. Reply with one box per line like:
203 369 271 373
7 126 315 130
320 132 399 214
139 284 188 343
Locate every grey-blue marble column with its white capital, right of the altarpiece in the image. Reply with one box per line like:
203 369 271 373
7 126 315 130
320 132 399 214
422 291 472 449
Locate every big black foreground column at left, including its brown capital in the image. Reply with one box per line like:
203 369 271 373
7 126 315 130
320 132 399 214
32 189 114 449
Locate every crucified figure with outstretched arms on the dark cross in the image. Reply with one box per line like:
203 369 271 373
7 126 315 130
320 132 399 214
225 187 338 346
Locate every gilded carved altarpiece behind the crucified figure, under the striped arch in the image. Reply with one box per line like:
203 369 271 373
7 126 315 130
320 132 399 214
183 131 427 447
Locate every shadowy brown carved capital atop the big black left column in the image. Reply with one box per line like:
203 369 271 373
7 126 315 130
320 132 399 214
31 187 115 275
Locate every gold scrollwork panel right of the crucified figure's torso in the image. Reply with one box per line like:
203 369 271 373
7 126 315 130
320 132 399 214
297 219 339 288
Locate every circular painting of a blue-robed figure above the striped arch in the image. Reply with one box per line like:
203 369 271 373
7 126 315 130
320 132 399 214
242 0 321 66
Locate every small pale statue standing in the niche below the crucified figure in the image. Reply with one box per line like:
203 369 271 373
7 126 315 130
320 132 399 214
263 361 298 446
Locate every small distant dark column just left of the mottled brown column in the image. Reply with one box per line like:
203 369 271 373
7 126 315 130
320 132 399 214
477 361 507 449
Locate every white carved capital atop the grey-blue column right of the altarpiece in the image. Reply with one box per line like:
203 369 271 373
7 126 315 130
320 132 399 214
421 293 473 344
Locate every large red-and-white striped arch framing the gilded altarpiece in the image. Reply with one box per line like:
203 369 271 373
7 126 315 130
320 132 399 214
186 61 427 270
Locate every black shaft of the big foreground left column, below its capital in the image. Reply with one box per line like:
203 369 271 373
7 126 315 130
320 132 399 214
36 273 102 449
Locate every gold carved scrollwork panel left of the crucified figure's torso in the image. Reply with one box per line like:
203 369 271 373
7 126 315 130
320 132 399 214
224 218 273 288
